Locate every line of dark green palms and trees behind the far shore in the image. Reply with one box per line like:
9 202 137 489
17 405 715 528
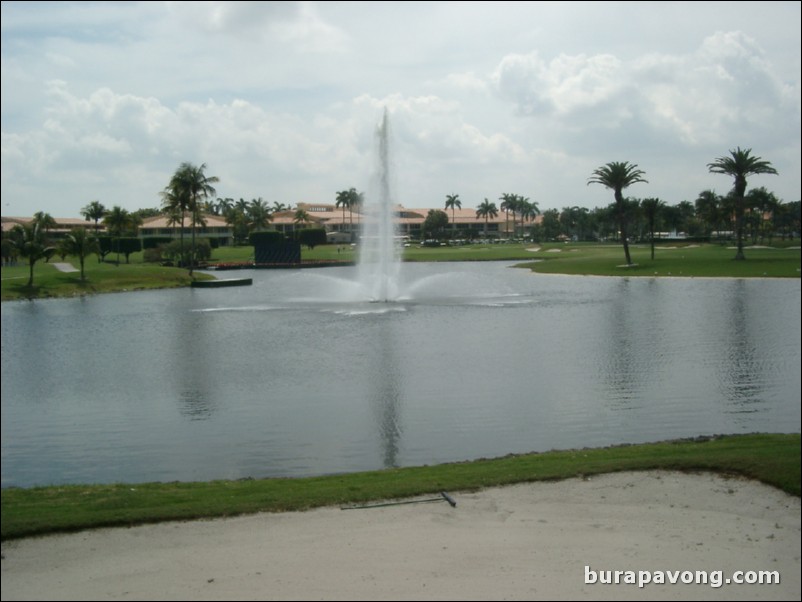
3 147 800 286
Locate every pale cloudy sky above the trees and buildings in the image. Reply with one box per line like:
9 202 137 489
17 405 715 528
0 1 802 217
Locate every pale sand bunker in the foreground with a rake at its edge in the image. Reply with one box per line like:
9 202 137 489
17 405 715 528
2 472 800 600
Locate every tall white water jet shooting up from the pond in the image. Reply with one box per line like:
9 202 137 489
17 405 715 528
359 108 400 302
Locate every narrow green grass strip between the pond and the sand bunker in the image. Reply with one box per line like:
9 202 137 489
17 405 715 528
2 434 800 539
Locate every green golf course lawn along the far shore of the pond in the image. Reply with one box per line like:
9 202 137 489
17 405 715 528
2 243 800 301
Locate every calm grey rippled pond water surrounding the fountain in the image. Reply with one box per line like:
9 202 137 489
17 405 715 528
2 263 801 487
